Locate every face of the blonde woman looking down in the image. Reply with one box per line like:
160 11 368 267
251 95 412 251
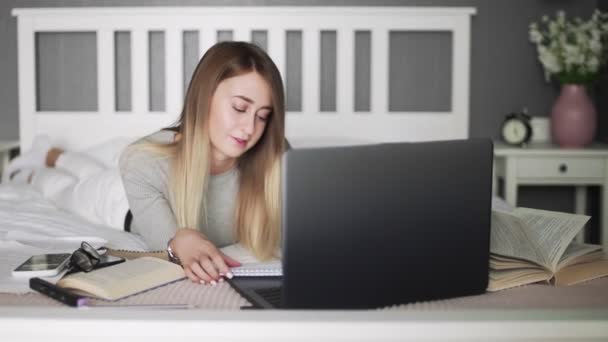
209 72 272 163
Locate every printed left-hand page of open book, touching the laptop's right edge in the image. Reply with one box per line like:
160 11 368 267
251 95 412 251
490 210 545 265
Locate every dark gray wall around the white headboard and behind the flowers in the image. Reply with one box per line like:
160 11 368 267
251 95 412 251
0 0 608 239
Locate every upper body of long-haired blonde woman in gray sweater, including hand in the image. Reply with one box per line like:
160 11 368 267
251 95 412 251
120 42 286 285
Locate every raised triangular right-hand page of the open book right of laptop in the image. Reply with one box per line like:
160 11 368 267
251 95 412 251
513 208 589 272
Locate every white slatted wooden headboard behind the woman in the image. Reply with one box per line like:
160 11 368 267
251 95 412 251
12 7 475 149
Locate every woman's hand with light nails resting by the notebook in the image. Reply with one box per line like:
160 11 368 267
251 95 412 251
171 228 241 285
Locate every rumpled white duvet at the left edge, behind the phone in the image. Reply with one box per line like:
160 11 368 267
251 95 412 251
0 183 147 292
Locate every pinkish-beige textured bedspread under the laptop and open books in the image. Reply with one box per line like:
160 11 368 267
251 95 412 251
0 278 608 311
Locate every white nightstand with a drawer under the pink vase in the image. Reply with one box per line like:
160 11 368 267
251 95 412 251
494 142 608 250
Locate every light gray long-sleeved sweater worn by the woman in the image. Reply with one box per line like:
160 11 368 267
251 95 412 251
120 130 239 250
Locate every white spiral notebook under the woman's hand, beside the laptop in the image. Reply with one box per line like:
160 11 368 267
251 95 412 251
220 244 283 277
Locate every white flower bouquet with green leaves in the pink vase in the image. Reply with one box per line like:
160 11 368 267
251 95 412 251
530 10 608 85
